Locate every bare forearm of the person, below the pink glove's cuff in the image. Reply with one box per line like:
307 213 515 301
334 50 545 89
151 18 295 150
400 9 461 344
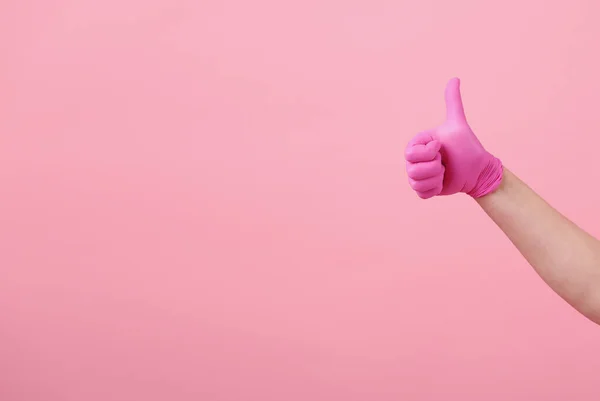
476 169 600 324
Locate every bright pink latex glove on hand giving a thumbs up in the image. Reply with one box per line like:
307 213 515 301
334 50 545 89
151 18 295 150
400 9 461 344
405 78 503 199
